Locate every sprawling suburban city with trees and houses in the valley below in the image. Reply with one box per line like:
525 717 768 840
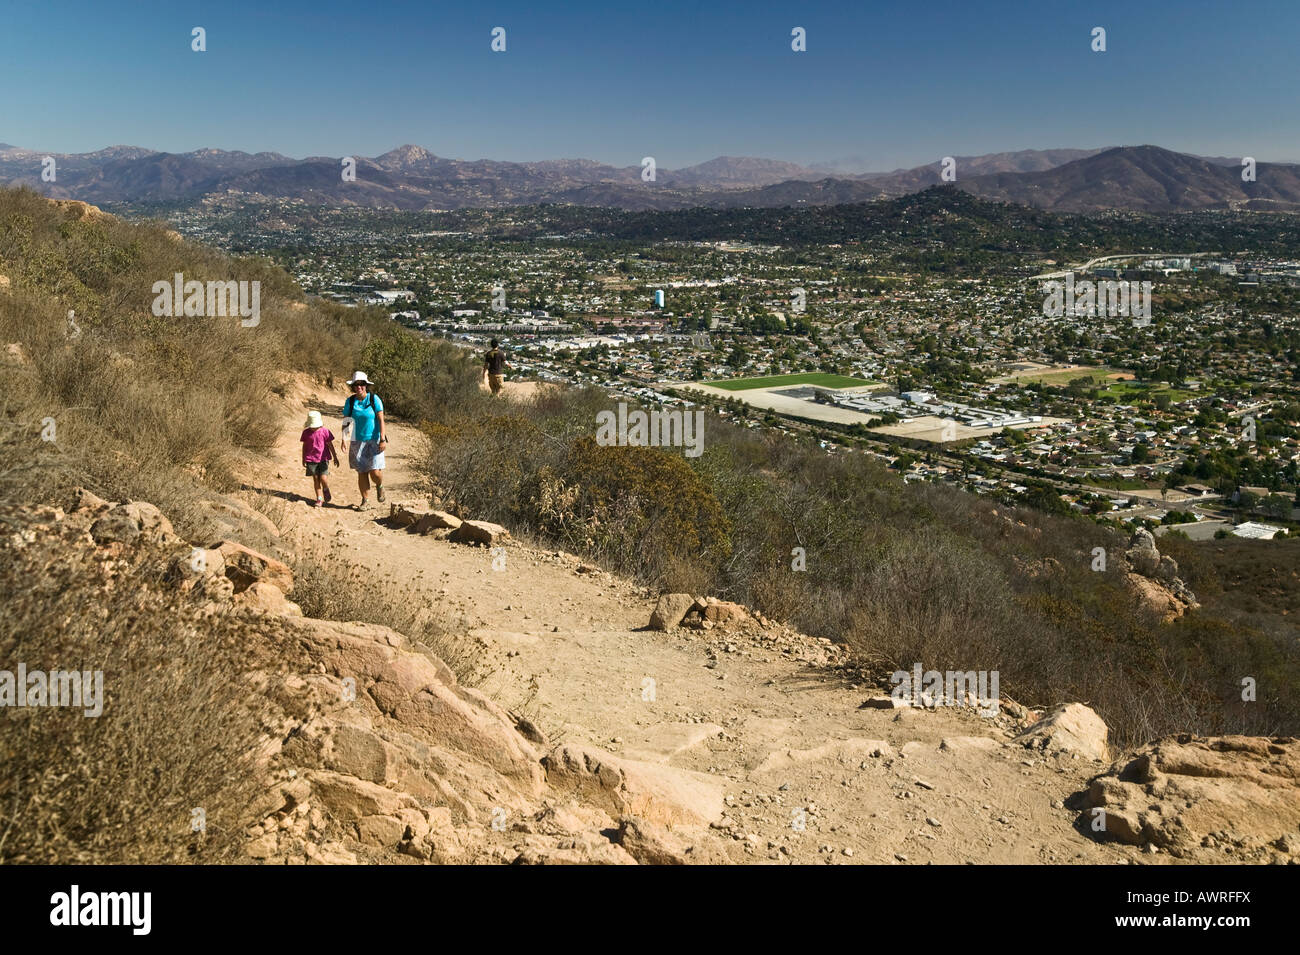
104 174 1300 539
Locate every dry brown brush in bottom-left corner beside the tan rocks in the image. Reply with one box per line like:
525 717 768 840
0 508 293 864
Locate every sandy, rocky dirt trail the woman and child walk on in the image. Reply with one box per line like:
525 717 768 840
250 382 1149 864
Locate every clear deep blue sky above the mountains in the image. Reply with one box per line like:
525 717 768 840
0 0 1300 169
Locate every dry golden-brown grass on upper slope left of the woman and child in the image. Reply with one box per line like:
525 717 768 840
0 190 384 524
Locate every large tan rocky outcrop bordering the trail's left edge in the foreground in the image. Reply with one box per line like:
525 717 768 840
14 489 743 865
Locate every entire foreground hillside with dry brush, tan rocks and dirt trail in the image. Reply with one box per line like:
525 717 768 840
0 192 1300 863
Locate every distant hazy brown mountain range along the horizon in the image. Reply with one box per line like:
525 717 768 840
0 144 1300 213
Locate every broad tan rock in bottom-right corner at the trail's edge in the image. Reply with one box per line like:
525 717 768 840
1078 735 1300 861
